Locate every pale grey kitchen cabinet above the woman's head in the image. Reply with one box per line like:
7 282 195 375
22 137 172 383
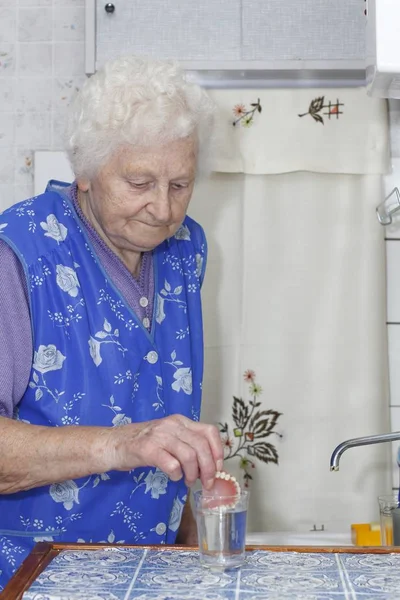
86 0 366 70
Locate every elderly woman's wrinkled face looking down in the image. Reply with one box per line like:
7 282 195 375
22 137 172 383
78 136 197 252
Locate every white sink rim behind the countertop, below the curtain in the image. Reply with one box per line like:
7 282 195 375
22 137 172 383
246 531 353 546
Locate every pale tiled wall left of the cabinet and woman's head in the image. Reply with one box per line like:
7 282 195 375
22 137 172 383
0 0 85 210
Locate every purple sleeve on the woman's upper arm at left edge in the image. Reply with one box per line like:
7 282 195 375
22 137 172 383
0 240 33 417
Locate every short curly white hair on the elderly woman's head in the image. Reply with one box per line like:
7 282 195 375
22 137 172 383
66 56 215 179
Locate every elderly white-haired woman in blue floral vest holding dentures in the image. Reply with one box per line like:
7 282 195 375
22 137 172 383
0 58 223 585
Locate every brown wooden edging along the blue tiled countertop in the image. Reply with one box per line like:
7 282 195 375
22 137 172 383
0 542 400 600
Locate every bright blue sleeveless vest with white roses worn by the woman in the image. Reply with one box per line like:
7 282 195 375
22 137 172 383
0 182 206 585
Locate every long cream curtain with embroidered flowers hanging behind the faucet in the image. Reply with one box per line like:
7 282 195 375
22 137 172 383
190 90 390 531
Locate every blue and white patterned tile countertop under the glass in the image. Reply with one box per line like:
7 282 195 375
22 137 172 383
23 548 400 600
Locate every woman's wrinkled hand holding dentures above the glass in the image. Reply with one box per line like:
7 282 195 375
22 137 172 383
106 415 223 489
